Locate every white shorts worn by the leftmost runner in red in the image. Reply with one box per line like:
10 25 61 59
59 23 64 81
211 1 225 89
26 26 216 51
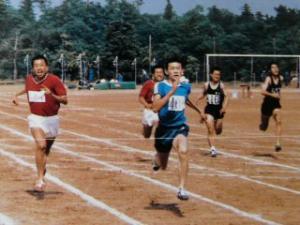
27 114 59 138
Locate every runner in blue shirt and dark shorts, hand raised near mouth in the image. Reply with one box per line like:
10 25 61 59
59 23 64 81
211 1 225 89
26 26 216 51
152 59 203 200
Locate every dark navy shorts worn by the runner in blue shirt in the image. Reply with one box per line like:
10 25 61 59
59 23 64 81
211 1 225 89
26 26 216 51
154 124 190 153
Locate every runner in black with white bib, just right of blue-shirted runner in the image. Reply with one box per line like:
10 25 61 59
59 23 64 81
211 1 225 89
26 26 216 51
198 67 228 157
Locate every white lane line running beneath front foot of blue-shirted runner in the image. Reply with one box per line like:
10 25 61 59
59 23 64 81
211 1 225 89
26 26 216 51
1 125 279 225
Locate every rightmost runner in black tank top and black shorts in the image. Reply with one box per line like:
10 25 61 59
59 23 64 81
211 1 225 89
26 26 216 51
259 63 283 151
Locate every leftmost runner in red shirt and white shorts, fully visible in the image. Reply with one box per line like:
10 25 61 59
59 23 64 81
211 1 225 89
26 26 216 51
13 55 68 192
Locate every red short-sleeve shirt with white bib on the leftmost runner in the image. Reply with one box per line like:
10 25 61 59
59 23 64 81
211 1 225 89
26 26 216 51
25 74 67 116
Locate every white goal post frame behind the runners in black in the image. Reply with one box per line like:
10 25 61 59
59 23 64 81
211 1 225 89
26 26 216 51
206 54 300 88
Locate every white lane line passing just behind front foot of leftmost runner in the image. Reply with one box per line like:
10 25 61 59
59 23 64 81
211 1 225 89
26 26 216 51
0 148 142 225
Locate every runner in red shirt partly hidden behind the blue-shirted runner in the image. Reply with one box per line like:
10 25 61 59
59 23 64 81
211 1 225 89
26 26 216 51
139 65 164 138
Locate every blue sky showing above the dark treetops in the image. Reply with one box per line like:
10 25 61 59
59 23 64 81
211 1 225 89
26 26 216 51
10 0 300 15
